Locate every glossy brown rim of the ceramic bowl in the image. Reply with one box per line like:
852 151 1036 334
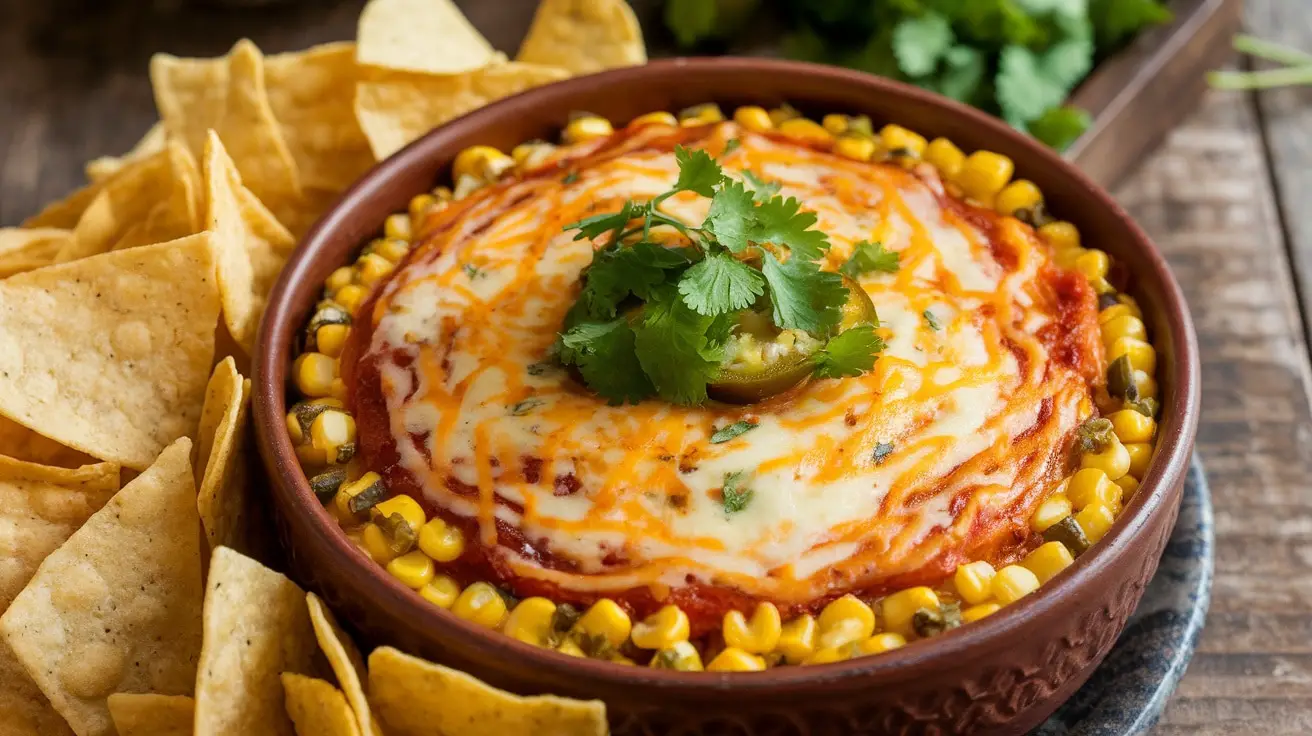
252 56 1199 694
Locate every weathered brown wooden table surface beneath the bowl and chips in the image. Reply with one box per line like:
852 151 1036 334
0 0 1312 736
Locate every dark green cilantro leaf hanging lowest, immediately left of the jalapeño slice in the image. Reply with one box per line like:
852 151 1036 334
634 286 724 405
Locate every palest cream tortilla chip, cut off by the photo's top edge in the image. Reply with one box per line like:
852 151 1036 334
356 0 496 75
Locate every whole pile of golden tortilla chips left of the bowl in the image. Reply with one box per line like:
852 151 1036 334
0 0 646 736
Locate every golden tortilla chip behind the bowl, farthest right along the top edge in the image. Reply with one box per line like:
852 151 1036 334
516 0 647 75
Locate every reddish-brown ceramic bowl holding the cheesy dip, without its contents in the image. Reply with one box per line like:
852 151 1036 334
255 58 1198 735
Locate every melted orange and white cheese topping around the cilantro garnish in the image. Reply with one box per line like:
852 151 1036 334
362 123 1101 606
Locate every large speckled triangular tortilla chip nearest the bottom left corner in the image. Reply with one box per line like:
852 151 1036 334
0 437 201 736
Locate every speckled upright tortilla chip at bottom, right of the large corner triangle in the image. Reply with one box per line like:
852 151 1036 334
195 547 315 736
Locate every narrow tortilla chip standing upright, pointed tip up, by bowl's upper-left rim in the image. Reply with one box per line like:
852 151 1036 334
205 131 294 354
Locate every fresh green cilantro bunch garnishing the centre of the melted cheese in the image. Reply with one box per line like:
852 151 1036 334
555 147 881 405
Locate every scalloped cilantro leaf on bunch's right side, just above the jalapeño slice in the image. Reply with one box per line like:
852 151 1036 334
761 251 848 333
